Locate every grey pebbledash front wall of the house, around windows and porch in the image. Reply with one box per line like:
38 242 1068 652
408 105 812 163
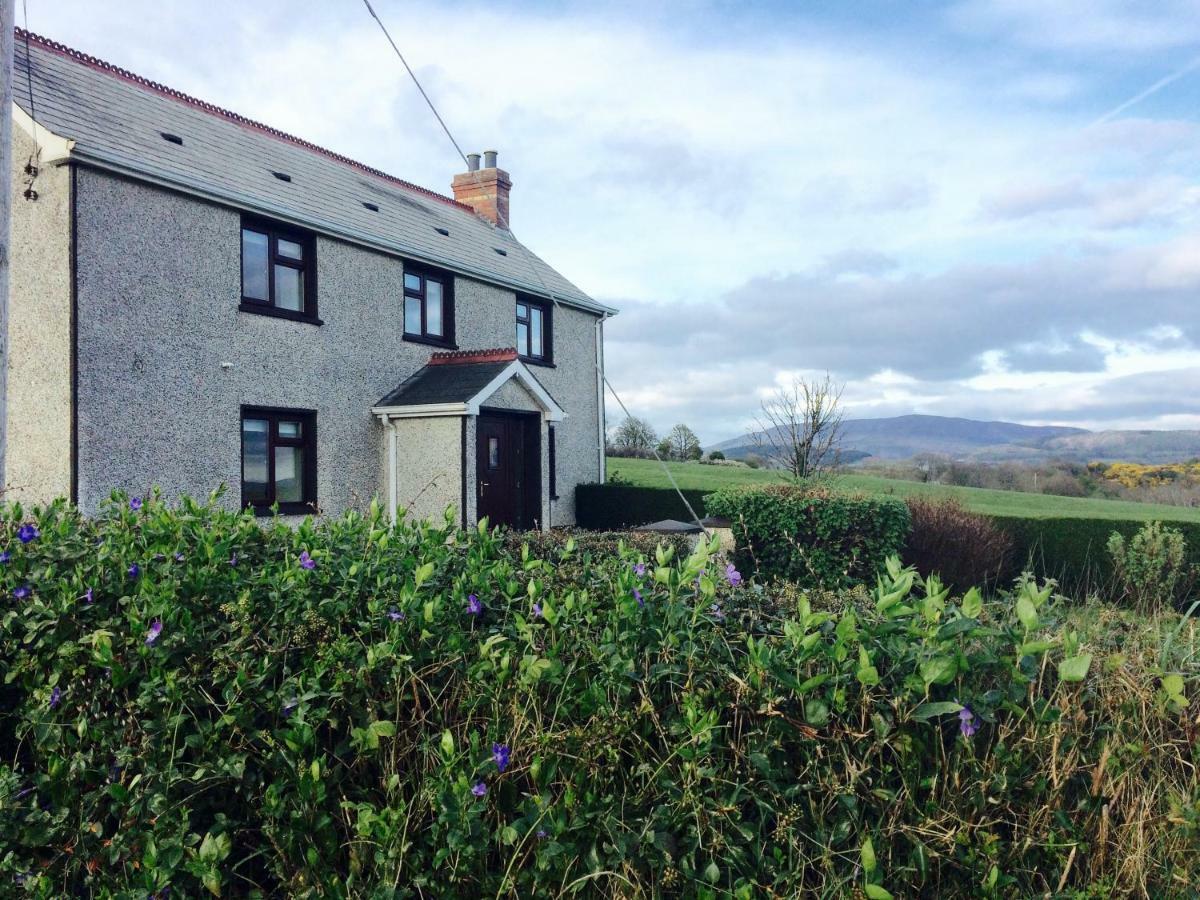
64 167 600 526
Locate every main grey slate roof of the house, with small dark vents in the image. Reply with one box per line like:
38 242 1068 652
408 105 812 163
13 29 616 313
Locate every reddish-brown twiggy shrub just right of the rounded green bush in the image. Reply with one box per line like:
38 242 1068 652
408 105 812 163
904 497 1013 590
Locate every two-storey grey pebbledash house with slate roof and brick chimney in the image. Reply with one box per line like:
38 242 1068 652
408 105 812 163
4 30 614 528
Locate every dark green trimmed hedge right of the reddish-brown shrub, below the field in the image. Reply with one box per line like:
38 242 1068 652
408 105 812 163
991 516 1200 596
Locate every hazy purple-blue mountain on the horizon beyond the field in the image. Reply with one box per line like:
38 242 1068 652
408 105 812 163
708 415 1200 463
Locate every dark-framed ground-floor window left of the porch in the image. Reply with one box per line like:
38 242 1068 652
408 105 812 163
241 407 317 515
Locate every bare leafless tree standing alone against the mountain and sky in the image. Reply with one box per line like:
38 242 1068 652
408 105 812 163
754 373 842 480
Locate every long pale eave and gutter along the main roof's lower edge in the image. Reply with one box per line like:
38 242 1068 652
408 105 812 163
70 142 617 316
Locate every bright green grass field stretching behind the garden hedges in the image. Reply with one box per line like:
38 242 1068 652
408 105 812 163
608 457 1200 522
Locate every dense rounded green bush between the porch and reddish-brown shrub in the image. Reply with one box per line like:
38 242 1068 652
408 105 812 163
704 485 908 588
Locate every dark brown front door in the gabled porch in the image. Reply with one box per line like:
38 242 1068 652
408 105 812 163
475 413 541 528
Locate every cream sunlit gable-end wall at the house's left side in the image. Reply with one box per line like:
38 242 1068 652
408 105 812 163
4 122 71 504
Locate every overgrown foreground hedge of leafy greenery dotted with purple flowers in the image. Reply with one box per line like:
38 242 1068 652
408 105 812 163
0 498 1200 898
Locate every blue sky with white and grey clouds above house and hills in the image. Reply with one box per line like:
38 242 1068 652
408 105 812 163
18 0 1200 444
